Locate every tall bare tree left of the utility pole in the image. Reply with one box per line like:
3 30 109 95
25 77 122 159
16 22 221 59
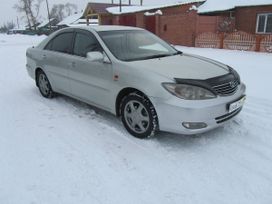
14 0 43 30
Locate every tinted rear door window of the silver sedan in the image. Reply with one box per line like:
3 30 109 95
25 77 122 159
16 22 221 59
49 33 73 53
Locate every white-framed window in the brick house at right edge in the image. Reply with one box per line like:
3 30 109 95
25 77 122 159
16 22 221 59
256 13 272 34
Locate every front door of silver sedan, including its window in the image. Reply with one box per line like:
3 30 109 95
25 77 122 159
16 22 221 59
69 30 112 110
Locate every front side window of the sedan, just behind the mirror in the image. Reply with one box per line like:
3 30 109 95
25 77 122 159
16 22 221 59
74 33 103 57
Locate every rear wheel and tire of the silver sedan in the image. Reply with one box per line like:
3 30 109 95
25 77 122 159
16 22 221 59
36 70 54 98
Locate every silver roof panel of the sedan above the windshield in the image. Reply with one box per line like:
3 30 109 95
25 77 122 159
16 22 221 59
69 25 143 32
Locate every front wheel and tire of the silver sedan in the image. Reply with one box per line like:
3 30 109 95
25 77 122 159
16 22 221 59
120 93 158 139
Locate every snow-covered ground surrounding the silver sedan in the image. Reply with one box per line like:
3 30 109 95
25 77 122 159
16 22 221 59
0 35 272 204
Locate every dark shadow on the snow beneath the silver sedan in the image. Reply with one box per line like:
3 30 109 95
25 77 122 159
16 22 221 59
41 94 238 149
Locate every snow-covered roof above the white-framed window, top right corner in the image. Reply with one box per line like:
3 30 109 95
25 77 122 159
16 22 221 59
198 0 272 14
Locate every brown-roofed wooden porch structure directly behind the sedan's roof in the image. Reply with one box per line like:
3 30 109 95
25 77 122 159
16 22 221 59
83 3 121 25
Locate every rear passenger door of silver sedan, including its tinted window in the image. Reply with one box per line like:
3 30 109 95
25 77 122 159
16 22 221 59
42 31 74 93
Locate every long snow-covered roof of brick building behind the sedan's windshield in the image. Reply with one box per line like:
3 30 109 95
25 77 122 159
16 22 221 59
107 0 206 15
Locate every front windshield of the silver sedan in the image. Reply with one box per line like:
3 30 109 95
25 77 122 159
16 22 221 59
99 30 179 61
